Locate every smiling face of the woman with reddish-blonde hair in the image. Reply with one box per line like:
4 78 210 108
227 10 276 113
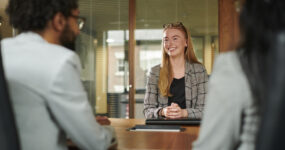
163 29 187 57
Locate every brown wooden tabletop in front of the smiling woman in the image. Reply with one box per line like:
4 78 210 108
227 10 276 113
110 118 199 150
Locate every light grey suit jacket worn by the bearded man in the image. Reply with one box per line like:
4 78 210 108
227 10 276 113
2 32 112 150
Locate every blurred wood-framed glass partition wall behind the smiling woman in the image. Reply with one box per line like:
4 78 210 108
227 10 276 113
0 0 237 118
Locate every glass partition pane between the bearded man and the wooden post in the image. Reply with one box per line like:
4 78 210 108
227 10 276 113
77 0 128 117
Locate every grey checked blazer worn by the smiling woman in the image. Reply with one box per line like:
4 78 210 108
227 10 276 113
143 61 208 118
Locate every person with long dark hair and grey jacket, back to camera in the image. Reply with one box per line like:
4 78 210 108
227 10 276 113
193 0 285 150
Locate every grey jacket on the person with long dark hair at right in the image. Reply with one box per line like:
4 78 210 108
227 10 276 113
193 51 260 150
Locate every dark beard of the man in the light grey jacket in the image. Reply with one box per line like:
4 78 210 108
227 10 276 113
59 24 76 51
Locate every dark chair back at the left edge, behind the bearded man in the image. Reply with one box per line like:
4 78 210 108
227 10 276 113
0 43 20 150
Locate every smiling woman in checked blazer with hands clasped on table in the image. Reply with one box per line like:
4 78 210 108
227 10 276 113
143 22 208 119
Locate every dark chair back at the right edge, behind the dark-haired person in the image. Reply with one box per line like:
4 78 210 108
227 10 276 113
256 32 285 150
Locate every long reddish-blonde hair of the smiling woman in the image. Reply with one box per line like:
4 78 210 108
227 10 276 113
158 22 200 96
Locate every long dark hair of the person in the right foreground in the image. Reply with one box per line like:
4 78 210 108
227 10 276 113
238 0 285 106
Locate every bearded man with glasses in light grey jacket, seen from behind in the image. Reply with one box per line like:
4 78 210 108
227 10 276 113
2 0 113 150
